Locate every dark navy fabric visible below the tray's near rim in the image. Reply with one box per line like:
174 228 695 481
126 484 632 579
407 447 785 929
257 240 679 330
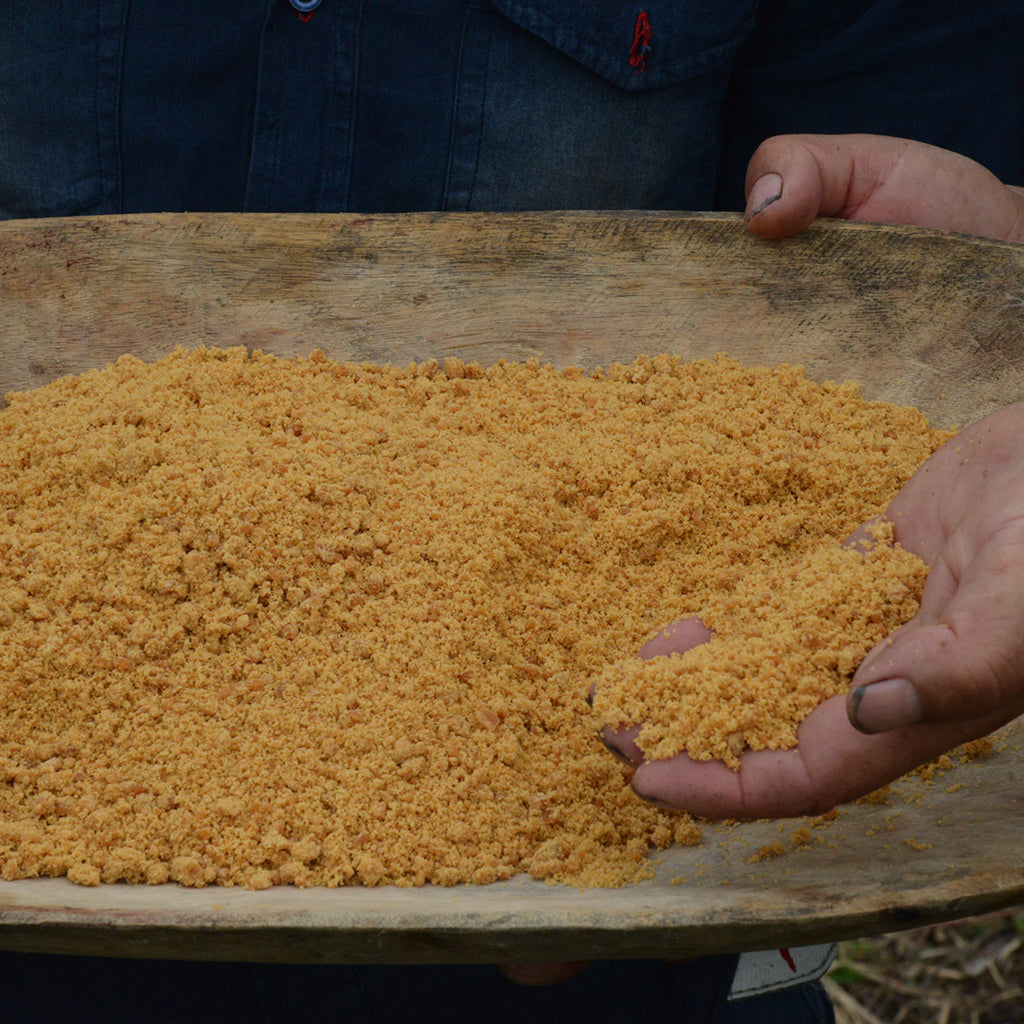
0 953 835 1024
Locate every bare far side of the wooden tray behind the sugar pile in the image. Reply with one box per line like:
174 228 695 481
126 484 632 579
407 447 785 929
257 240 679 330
6 214 1024 421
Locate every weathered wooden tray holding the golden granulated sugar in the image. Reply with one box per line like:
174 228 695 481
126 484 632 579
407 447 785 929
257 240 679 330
0 214 1024 963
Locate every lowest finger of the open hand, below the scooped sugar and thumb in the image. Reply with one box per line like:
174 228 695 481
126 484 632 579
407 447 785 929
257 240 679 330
633 696 1009 819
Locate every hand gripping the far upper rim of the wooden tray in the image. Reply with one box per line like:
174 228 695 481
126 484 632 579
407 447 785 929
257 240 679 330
744 135 1024 242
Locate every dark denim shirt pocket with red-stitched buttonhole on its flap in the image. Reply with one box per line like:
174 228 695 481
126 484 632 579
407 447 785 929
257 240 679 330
444 0 757 210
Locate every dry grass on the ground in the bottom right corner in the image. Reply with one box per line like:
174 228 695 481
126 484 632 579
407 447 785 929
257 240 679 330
825 907 1024 1024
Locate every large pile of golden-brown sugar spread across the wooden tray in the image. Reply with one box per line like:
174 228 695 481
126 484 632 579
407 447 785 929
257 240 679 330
0 349 944 887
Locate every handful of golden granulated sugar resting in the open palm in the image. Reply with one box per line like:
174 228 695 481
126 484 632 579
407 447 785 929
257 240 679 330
594 524 928 768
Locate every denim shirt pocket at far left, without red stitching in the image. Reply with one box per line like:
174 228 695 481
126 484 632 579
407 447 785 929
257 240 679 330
0 0 128 218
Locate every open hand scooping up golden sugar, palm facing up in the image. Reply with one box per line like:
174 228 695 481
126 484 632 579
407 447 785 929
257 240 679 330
605 402 1024 818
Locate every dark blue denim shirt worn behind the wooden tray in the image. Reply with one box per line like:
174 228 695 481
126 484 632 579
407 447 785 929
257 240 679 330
6 0 1024 217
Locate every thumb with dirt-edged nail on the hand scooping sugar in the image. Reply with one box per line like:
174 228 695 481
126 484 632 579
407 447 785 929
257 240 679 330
847 524 1024 734
